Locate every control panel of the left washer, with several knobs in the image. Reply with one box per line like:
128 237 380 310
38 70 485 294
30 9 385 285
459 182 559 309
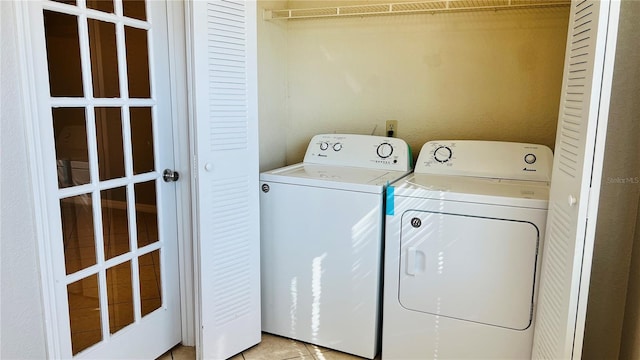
304 134 412 171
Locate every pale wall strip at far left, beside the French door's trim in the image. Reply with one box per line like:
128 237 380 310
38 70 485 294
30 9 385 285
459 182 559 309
0 1 46 359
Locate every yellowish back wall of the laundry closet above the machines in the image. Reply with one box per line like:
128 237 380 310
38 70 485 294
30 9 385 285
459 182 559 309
272 1 568 164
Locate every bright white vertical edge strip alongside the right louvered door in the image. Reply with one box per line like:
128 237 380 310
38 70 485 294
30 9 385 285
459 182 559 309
572 1 620 359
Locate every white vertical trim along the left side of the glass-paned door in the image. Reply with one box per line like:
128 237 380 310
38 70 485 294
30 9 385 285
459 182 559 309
14 1 61 358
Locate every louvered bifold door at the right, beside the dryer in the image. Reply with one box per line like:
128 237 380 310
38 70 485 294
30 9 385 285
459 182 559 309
533 0 611 359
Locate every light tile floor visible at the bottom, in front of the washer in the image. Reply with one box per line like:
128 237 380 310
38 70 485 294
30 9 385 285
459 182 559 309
158 333 380 360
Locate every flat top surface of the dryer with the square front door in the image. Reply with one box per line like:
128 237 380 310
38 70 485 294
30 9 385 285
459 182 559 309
394 173 549 209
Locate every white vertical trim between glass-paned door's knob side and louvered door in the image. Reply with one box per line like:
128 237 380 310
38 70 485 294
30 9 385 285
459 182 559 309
167 1 196 346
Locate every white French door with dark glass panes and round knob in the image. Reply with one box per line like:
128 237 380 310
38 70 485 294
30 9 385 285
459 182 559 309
25 0 181 359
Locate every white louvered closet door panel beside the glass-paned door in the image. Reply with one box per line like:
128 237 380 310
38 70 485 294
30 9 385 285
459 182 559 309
190 0 260 359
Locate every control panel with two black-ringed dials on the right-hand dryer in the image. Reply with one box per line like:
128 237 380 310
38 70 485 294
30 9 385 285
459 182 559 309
415 140 553 181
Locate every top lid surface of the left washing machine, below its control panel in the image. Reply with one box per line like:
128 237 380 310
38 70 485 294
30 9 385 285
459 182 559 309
260 163 408 193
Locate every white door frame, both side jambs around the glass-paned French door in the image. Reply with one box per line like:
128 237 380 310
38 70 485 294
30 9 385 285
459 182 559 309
14 1 195 358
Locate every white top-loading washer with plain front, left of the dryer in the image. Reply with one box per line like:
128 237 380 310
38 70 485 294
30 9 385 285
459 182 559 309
260 134 411 358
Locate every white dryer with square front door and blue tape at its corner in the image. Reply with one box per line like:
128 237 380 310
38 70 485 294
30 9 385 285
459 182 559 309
382 141 553 360
